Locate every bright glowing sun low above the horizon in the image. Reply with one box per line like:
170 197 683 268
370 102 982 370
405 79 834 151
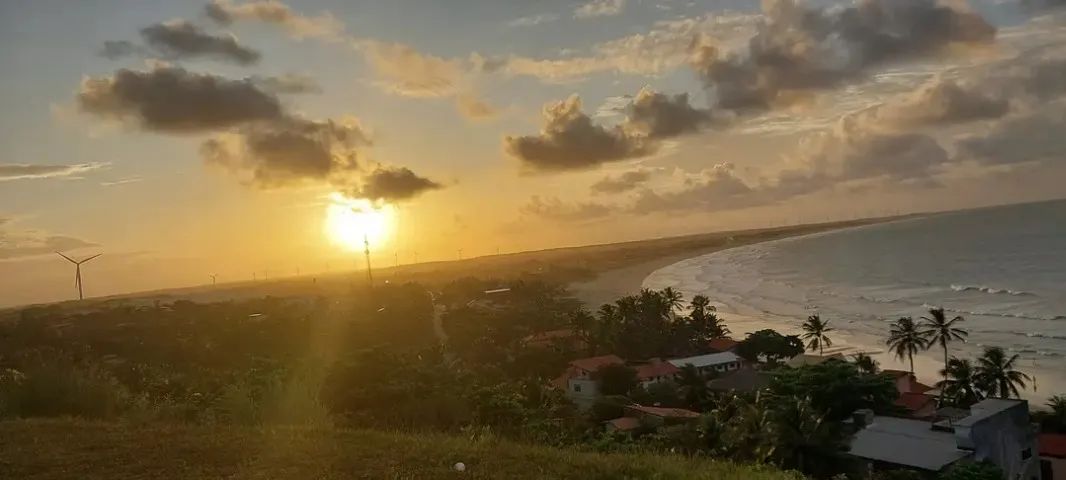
325 192 393 251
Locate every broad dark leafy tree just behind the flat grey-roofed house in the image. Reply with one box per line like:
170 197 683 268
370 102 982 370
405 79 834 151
770 359 899 421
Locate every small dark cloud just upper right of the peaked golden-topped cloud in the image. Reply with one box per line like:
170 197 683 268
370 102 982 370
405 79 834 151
625 87 713 139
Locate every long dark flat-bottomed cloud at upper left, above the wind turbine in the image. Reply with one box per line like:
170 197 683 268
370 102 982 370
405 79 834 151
77 65 281 133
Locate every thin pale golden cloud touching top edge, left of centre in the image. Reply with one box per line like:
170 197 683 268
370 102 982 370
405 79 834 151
204 0 344 39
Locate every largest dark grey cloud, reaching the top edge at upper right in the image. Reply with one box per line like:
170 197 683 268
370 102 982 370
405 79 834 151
692 0 996 110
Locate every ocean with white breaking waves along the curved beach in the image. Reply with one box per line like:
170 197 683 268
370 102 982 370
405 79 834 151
644 201 1066 401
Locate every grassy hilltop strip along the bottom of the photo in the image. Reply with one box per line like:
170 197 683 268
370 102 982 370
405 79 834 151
0 420 800 480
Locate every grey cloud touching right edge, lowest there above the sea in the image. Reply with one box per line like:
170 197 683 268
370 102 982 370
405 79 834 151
957 102 1066 164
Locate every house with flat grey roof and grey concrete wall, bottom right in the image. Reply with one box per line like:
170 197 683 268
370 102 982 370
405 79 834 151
849 399 1040 480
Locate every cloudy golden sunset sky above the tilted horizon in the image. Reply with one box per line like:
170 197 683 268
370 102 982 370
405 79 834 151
0 0 1066 306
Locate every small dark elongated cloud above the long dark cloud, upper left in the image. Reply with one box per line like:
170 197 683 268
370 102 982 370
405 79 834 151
139 20 260 65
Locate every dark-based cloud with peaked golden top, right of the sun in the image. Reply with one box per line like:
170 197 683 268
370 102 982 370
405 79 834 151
504 95 655 171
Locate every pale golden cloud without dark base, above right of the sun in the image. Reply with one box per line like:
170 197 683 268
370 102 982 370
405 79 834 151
355 41 464 97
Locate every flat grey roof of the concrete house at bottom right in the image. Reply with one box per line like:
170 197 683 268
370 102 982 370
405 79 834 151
849 416 970 471
